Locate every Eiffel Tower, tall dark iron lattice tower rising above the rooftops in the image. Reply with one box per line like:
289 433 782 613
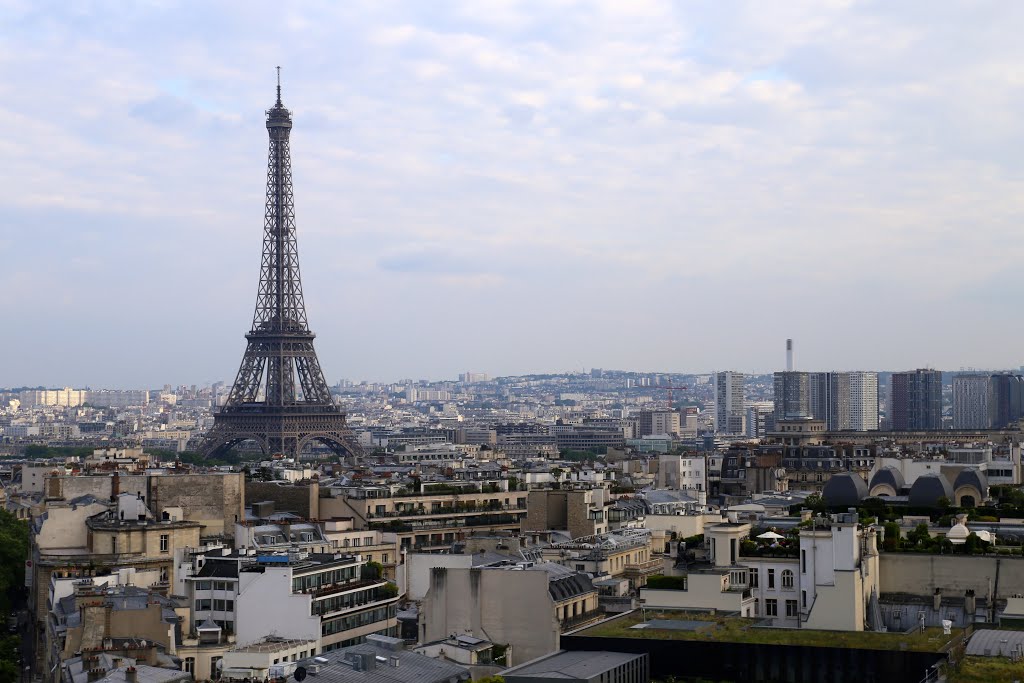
200 67 361 458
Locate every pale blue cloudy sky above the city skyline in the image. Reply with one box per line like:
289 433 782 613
0 0 1024 387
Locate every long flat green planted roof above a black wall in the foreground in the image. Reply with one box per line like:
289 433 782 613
574 609 958 655
